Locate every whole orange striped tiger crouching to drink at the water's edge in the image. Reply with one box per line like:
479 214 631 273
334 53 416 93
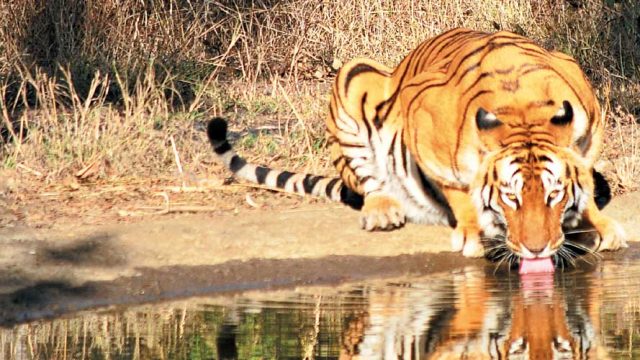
207 28 626 259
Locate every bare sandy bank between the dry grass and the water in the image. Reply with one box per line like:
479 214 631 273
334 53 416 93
0 193 640 325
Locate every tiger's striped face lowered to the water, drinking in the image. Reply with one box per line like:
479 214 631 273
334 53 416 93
473 145 586 259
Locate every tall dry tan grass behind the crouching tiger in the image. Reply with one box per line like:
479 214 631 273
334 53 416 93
0 0 640 195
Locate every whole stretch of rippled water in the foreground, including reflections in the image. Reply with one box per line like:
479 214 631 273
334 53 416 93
0 260 640 359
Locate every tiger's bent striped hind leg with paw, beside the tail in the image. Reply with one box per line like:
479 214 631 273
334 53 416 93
327 59 406 231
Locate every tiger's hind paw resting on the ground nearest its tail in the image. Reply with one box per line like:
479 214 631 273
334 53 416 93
360 194 406 231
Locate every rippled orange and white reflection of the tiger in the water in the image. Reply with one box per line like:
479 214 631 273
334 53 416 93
340 269 608 359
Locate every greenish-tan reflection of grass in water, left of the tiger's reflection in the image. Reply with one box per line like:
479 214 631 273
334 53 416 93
0 292 356 360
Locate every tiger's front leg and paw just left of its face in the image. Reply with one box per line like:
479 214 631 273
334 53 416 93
443 187 484 257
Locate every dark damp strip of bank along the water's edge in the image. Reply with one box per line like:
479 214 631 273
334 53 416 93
0 243 640 327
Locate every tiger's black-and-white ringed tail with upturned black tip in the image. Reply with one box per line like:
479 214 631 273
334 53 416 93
207 118 363 209
